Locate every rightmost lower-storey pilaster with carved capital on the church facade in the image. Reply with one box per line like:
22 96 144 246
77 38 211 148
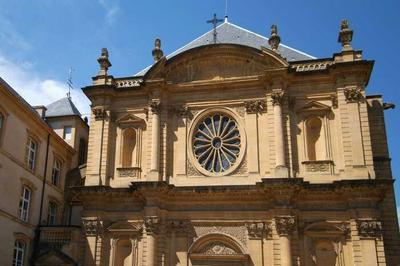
357 220 382 266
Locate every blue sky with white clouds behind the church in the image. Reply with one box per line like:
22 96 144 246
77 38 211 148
0 0 400 214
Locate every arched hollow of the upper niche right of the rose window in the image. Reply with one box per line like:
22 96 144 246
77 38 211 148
306 117 326 161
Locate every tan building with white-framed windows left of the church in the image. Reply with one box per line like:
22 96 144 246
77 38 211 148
0 78 88 266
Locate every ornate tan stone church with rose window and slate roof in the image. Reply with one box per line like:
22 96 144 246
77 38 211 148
54 19 400 266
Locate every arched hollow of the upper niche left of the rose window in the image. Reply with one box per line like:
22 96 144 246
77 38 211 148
121 128 136 167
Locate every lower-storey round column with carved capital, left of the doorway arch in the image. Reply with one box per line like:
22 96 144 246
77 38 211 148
144 216 159 266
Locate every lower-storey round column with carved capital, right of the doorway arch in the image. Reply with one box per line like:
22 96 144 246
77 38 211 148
275 216 296 266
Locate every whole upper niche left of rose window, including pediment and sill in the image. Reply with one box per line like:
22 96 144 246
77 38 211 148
115 114 146 182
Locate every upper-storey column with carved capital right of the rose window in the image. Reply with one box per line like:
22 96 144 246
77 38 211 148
271 90 288 177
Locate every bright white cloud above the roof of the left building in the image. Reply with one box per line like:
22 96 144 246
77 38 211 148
0 54 90 117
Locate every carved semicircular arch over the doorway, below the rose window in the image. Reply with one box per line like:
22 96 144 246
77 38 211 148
188 234 249 266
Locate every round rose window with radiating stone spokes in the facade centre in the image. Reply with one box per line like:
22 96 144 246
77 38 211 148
193 114 241 174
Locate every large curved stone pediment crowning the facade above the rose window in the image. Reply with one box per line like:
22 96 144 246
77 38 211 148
144 44 288 83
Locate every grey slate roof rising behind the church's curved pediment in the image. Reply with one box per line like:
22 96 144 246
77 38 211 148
135 20 315 76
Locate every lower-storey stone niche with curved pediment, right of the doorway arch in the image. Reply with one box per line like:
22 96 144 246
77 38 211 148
304 222 348 266
